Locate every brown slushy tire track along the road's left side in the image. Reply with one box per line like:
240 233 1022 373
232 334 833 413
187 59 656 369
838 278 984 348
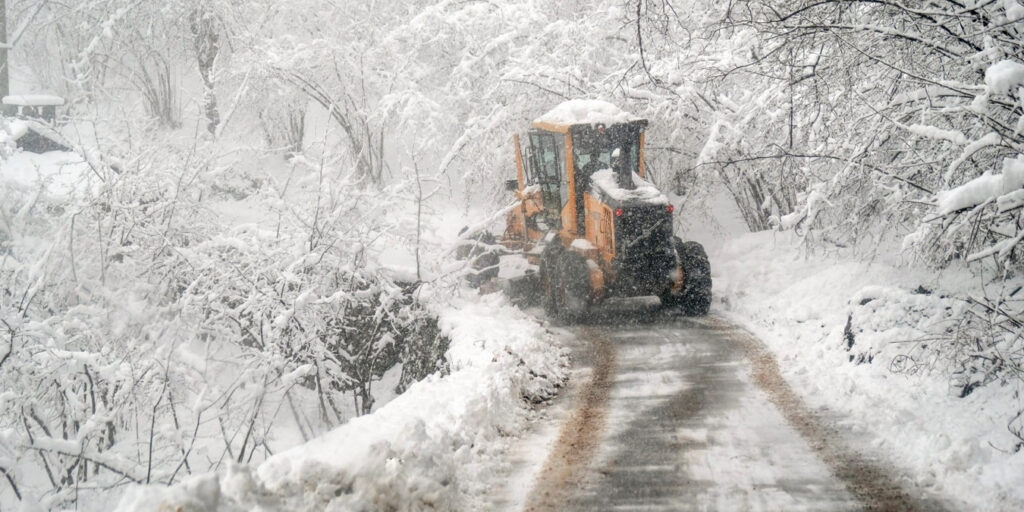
523 329 615 512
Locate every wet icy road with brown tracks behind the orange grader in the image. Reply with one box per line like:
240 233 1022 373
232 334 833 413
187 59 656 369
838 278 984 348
510 301 944 511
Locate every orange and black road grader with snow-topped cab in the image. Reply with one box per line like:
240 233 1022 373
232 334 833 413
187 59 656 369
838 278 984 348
500 99 712 319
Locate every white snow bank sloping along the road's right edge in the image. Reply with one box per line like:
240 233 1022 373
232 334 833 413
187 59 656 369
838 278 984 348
712 231 1024 510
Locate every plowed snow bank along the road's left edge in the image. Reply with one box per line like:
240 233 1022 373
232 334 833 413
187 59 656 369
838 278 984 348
112 294 566 512
